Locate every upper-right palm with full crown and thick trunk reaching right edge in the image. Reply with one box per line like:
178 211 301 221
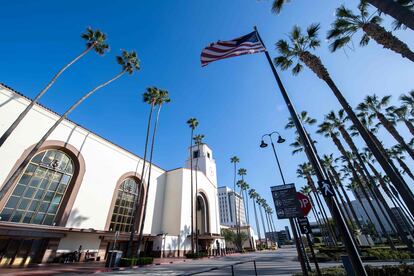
327 2 414 61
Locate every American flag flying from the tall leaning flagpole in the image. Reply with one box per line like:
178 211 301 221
201 31 266 66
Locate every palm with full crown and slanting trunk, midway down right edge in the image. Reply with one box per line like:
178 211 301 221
357 94 414 160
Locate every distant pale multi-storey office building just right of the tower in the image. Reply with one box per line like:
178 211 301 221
217 186 247 227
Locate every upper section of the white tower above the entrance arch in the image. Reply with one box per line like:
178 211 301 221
185 144 217 186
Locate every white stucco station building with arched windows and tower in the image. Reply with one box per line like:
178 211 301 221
0 85 224 265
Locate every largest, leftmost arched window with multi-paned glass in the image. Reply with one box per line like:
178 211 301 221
0 149 74 225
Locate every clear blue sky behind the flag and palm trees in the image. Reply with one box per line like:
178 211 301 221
0 0 414 232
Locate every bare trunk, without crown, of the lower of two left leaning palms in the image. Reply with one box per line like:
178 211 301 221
0 71 125 202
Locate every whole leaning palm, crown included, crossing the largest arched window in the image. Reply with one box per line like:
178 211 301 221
0 51 139 202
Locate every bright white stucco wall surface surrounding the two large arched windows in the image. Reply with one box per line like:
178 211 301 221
0 85 165 234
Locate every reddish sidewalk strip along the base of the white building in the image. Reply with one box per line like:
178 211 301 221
0 253 240 276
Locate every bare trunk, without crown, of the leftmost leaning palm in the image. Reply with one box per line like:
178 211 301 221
0 44 95 148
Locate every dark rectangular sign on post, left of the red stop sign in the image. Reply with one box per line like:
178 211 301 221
270 183 303 219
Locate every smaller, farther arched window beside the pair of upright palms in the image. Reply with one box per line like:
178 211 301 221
109 178 139 232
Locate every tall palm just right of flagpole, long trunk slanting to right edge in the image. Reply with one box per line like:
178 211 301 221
274 24 414 218
